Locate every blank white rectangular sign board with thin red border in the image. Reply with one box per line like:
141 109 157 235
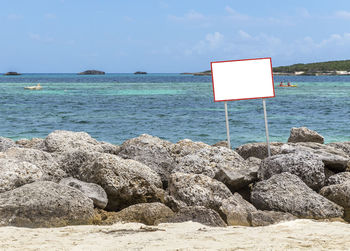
211 58 275 102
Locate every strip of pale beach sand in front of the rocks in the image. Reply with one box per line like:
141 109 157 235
0 220 350 251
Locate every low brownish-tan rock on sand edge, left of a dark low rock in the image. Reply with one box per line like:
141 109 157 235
116 202 174 225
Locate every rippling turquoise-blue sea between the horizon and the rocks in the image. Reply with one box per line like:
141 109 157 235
0 73 350 147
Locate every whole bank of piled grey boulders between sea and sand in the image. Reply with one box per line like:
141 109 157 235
0 127 350 227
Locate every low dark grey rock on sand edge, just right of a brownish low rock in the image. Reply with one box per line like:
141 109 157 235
158 206 227 227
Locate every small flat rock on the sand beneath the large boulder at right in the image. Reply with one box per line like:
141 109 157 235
248 210 297 227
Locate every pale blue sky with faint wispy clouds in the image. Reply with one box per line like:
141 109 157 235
0 0 350 73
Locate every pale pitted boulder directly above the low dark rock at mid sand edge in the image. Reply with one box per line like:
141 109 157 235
168 173 232 212
